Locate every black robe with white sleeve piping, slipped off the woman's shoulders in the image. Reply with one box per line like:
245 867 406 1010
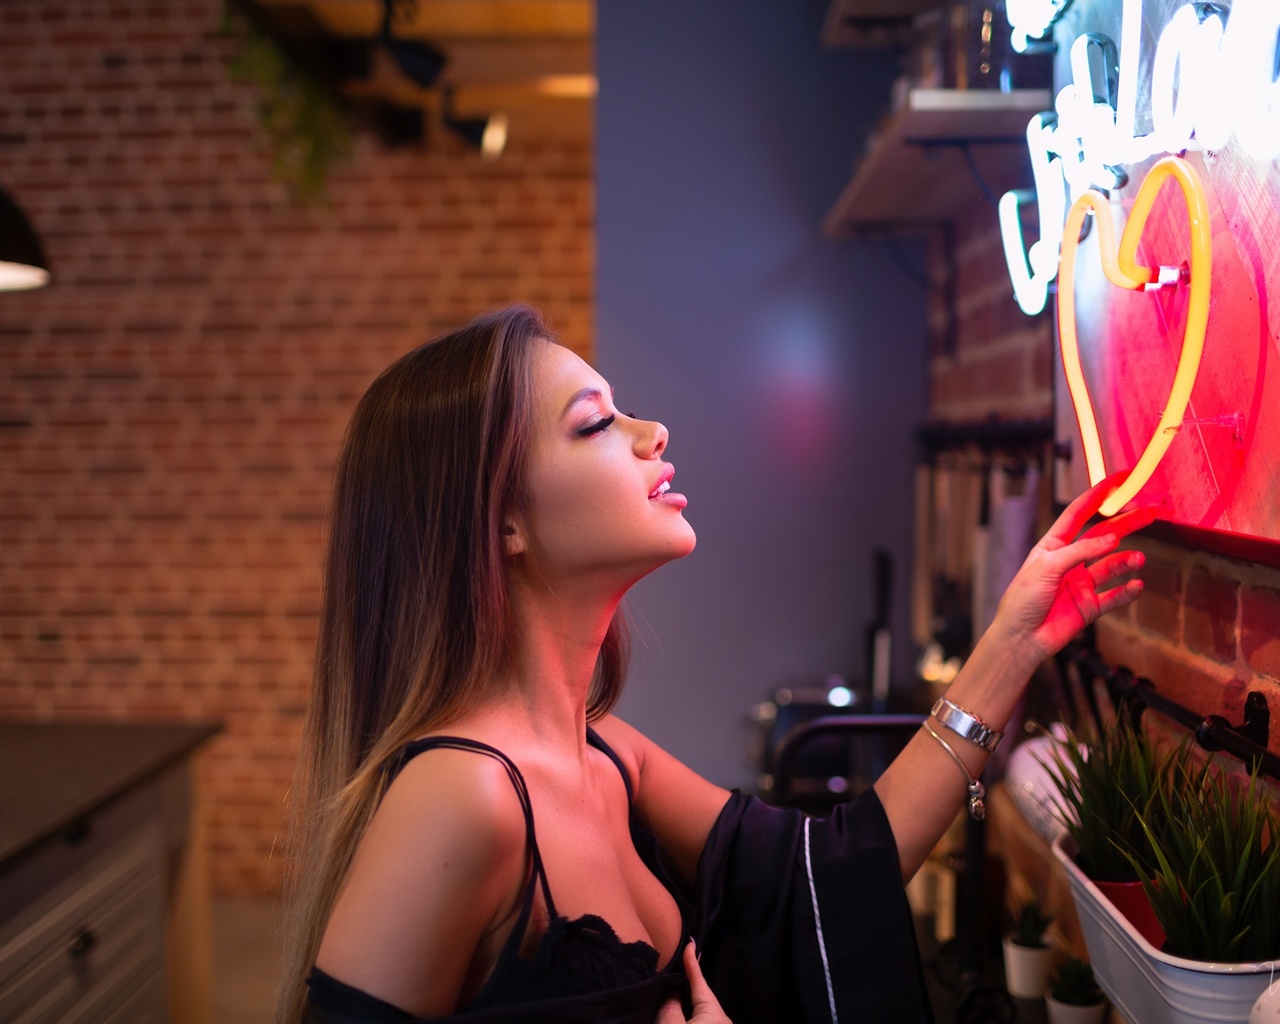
307 744 933 1024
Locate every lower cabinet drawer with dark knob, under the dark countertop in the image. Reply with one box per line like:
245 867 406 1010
0 826 164 1024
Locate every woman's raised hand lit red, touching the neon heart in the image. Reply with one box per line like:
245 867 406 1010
992 474 1156 664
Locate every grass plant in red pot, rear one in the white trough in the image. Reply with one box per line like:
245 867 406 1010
1042 716 1180 948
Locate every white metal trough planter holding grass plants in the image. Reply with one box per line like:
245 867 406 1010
1053 835 1275 1024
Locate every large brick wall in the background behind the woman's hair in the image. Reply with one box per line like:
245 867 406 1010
0 0 594 893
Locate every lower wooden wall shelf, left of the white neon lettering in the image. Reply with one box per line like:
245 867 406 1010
823 88 1053 236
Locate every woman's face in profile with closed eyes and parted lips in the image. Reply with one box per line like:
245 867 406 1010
517 343 695 586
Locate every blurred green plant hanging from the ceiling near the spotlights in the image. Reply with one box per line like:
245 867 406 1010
223 6 352 205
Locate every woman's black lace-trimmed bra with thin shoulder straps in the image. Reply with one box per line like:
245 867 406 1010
307 730 690 1024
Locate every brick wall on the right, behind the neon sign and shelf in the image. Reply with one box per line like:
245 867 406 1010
929 195 1280 764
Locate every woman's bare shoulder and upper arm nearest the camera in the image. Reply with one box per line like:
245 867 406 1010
316 749 526 1016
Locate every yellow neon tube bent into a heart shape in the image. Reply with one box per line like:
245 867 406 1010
1057 156 1212 516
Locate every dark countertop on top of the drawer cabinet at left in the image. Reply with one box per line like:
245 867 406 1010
0 721 221 865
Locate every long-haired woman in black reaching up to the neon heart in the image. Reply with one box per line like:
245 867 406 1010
279 307 1151 1024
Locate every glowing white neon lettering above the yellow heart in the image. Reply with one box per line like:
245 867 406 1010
998 0 1280 315
